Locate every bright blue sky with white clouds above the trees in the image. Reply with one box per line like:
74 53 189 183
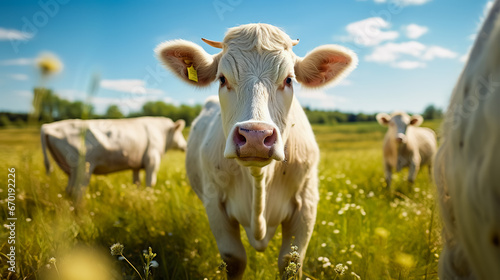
0 0 491 113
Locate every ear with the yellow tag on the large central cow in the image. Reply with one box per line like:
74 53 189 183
155 40 219 87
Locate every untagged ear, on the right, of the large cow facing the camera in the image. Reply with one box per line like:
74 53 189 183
295 45 358 87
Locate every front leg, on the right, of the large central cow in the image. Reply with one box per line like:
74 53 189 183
278 192 317 279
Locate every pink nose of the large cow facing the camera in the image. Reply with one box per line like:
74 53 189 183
233 123 277 160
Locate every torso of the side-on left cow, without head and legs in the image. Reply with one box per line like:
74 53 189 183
44 117 166 174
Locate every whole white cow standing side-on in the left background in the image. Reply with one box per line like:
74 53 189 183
41 117 186 201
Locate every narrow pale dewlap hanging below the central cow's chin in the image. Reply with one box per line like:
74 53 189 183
250 167 267 240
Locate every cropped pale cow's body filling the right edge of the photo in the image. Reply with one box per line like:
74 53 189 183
434 1 500 279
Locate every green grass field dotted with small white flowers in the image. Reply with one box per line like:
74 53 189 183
0 122 441 280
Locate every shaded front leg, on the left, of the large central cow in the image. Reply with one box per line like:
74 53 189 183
205 199 247 279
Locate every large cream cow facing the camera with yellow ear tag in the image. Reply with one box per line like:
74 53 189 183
156 24 357 279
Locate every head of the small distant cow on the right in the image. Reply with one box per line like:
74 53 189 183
376 112 424 143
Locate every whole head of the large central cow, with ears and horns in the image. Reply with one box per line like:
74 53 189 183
156 24 357 166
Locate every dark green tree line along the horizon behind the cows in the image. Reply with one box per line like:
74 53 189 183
0 88 443 127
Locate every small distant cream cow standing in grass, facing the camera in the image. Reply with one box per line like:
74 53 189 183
377 112 437 188
